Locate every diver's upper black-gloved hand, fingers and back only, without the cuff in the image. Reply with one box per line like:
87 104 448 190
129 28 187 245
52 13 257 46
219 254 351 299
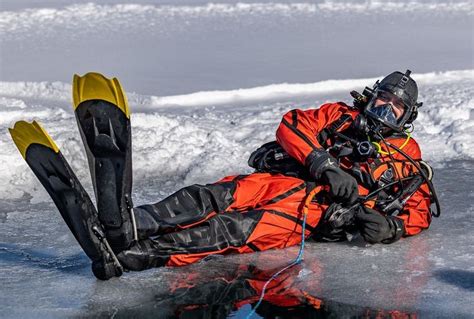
322 167 359 205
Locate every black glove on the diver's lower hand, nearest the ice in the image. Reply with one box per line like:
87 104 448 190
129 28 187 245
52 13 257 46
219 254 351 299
356 207 405 244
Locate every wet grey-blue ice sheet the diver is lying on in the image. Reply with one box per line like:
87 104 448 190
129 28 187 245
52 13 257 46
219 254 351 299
0 161 474 318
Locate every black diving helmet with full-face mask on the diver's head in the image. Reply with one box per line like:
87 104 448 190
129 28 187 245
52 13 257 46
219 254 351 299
365 70 422 132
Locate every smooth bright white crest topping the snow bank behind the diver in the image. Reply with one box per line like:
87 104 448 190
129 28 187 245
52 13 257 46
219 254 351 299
0 70 474 112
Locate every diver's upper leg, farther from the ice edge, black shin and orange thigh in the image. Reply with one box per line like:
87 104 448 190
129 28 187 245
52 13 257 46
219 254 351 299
133 173 305 239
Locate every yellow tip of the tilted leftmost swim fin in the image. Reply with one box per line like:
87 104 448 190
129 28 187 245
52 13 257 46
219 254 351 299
8 121 59 159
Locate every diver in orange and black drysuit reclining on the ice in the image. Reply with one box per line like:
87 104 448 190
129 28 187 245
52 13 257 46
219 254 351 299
11 70 439 280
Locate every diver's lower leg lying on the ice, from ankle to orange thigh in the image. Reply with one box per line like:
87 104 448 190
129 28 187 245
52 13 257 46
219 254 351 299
117 196 320 270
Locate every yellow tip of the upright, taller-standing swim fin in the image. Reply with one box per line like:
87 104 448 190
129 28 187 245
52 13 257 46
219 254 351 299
72 72 130 118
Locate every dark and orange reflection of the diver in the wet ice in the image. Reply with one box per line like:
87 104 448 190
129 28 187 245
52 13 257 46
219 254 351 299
87 254 422 318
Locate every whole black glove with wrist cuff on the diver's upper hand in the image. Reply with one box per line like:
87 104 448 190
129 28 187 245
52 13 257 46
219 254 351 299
306 150 359 204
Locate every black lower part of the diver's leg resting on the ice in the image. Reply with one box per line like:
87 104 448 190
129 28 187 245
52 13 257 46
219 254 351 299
117 211 264 270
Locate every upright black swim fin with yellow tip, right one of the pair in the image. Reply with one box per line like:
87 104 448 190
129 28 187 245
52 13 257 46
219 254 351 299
73 73 137 253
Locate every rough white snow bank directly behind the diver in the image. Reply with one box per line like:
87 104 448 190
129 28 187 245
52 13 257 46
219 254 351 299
0 70 474 201
